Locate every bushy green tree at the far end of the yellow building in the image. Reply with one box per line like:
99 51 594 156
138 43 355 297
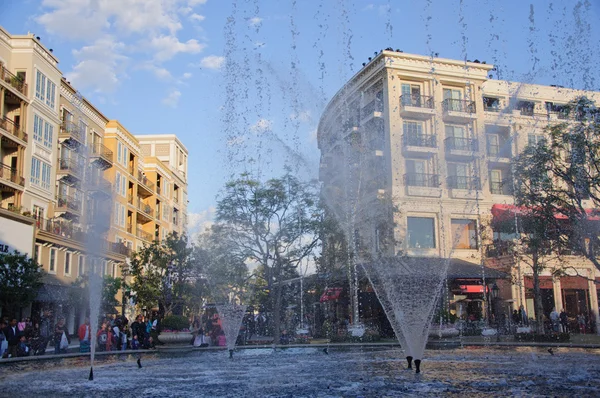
128 234 200 318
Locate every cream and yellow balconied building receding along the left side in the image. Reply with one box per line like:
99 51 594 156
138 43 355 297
0 27 187 332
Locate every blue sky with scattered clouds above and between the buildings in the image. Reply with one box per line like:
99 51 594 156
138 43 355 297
0 0 600 235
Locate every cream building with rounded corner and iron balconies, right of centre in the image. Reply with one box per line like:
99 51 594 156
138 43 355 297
318 51 600 326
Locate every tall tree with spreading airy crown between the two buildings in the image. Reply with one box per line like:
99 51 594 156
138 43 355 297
217 171 322 342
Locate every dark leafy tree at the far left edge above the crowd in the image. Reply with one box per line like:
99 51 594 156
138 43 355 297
0 250 42 316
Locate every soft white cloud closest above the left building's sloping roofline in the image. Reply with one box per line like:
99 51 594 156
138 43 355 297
65 36 128 93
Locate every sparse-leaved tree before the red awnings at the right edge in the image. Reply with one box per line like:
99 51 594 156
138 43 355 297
513 97 600 330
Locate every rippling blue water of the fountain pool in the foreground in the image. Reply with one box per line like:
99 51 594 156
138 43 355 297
0 346 600 397
